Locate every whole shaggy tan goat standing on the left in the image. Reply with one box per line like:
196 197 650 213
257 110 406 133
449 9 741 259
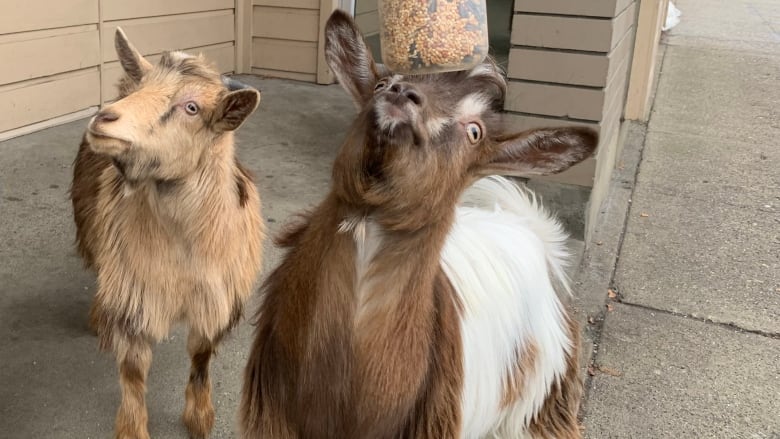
71 29 265 439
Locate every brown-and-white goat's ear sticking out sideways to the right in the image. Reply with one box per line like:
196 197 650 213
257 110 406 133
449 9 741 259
476 127 598 175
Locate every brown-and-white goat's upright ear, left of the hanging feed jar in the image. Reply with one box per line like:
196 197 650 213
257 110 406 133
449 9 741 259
325 10 379 108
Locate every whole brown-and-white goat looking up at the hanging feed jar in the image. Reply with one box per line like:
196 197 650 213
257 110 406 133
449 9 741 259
240 11 597 439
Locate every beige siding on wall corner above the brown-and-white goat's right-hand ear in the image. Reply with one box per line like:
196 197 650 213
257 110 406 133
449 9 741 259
505 0 636 186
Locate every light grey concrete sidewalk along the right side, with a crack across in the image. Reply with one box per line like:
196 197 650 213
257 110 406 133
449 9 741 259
580 0 780 439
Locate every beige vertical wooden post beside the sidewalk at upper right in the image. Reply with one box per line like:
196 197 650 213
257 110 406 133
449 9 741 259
625 0 669 121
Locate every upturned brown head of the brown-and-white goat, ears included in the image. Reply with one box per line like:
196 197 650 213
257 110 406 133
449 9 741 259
325 11 597 218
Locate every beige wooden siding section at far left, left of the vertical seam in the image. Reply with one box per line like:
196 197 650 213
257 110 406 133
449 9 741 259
0 0 100 140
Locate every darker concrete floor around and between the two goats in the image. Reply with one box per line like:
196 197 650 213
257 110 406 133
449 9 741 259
0 76 583 439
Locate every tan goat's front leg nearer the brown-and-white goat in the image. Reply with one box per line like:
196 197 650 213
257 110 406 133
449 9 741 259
182 330 215 439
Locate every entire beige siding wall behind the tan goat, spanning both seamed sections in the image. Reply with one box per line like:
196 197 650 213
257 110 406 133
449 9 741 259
0 0 236 140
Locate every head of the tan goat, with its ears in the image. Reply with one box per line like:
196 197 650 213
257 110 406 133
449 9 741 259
87 29 260 181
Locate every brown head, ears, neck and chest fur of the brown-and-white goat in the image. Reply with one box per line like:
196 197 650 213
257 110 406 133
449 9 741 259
240 12 596 439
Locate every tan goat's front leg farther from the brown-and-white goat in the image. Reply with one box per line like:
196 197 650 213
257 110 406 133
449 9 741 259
115 337 152 439
